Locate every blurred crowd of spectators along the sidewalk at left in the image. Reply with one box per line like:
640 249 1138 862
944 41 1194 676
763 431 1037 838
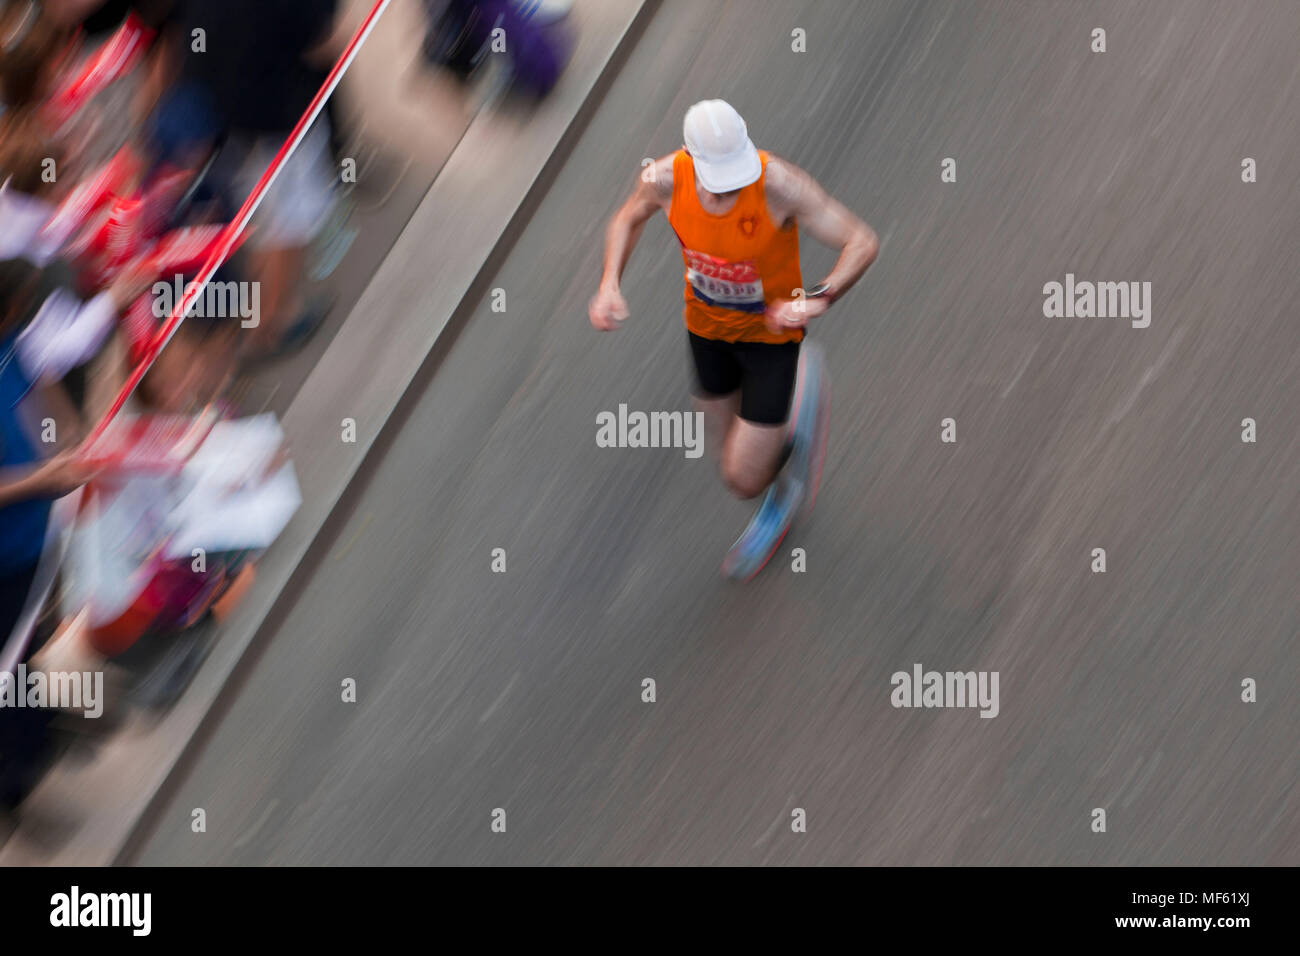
0 0 569 809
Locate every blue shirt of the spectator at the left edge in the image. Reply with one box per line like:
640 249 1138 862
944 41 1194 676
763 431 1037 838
0 333 51 575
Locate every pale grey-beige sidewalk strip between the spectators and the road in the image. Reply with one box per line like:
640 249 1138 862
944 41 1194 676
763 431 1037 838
0 0 655 865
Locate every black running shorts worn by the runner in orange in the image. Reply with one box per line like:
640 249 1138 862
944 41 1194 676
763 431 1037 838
686 332 800 425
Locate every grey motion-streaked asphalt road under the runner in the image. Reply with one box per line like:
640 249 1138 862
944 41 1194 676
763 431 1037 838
131 0 1300 865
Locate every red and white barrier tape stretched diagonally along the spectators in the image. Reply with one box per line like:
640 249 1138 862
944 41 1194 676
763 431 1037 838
86 0 391 445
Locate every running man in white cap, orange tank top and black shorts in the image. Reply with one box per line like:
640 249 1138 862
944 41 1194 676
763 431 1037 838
588 100 880 578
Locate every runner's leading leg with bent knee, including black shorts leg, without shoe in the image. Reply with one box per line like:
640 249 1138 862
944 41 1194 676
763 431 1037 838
723 342 800 498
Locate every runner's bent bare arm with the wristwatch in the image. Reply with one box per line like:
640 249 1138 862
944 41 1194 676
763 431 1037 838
766 157 880 299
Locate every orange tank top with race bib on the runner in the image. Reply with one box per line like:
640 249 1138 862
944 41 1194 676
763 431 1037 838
668 150 803 343
